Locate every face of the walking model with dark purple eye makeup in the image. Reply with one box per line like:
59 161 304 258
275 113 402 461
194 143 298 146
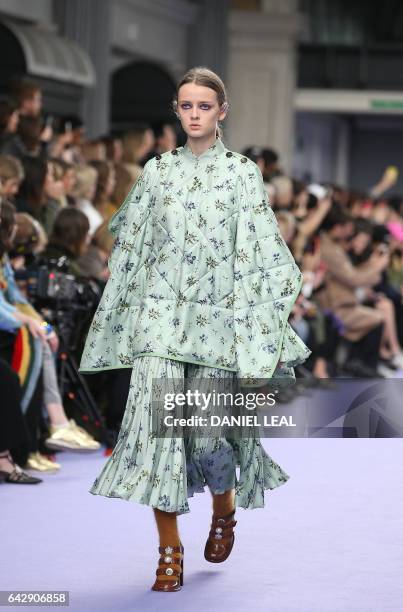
178 83 226 138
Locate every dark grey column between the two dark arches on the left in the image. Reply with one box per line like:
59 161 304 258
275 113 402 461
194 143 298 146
54 0 112 137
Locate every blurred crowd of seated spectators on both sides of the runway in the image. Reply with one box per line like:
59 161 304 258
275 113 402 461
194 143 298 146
0 81 403 484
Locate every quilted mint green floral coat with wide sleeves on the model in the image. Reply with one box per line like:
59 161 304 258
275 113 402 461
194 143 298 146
80 139 310 382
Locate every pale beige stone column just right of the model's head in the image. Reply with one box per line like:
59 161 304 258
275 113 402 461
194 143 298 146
227 0 300 172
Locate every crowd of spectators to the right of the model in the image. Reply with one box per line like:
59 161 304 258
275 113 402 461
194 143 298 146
243 146 403 392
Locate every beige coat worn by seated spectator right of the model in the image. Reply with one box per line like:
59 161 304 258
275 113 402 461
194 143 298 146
318 232 384 342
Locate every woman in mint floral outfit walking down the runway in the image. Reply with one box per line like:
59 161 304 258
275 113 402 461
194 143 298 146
80 68 310 591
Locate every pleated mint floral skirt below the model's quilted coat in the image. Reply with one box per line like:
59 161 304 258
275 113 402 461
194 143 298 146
89 355 289 514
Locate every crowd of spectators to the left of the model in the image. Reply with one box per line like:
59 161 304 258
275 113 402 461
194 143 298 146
0 80 172 484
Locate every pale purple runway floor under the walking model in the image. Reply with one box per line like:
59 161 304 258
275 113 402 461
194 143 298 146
0 439 403 612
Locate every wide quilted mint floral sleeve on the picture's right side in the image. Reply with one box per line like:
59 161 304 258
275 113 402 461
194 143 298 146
234 162 311 381
